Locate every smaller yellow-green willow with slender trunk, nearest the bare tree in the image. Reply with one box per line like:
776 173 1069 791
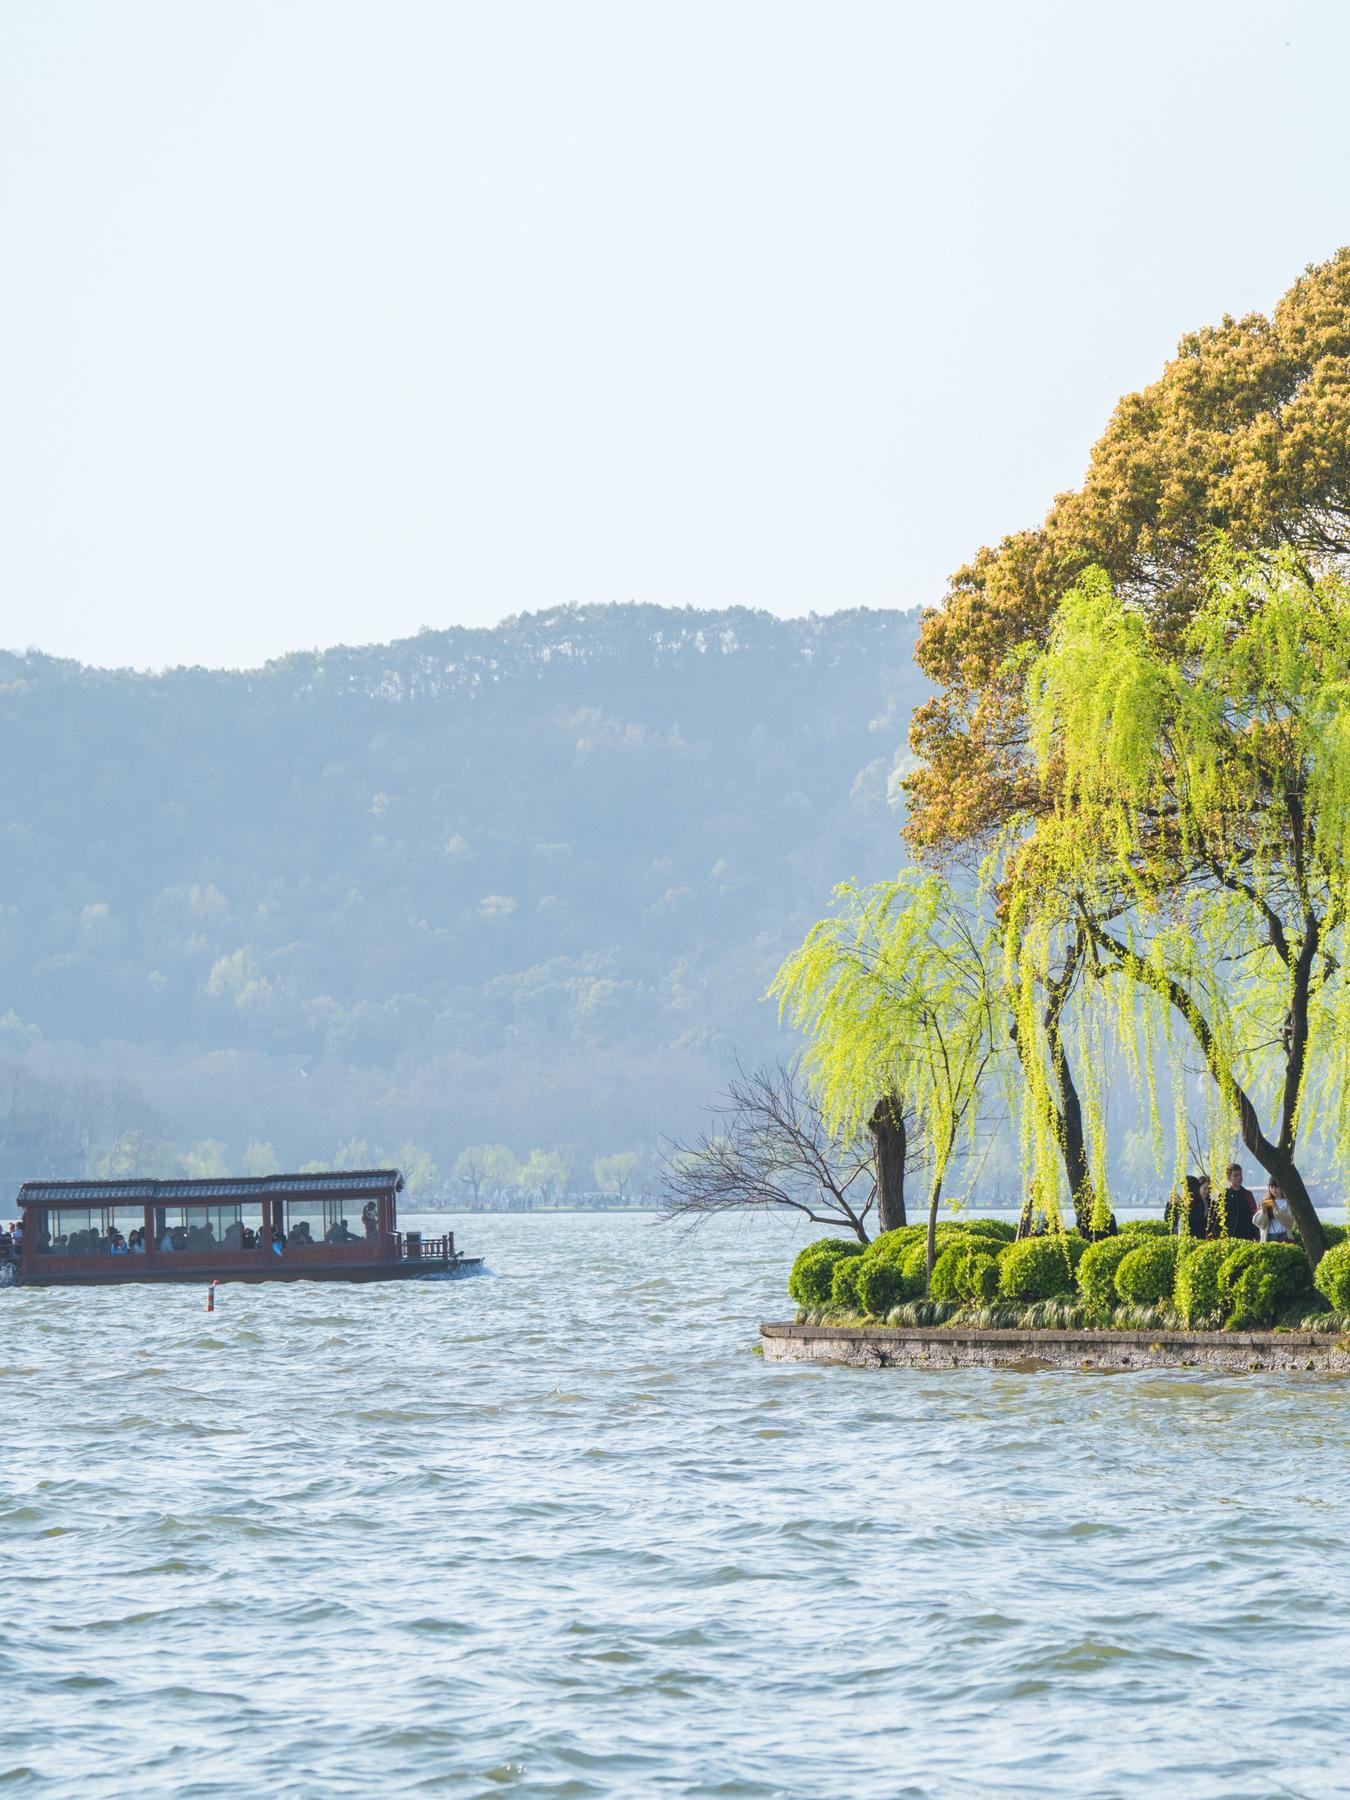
770 873 1006 1274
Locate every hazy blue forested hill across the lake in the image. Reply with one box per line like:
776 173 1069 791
0 605 922 1177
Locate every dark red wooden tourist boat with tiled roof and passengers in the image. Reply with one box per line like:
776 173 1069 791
0 1168 482 1287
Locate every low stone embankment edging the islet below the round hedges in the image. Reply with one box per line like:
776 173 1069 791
760 1325 1350 1375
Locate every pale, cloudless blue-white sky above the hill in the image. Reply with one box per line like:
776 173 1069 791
0 0 1350 668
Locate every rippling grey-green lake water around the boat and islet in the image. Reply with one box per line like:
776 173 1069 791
0 1215 1350 1800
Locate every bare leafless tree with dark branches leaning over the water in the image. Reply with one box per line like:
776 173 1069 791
661 1064 903 1244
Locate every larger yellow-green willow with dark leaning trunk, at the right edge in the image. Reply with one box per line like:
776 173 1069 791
1004 544 1350 1265
